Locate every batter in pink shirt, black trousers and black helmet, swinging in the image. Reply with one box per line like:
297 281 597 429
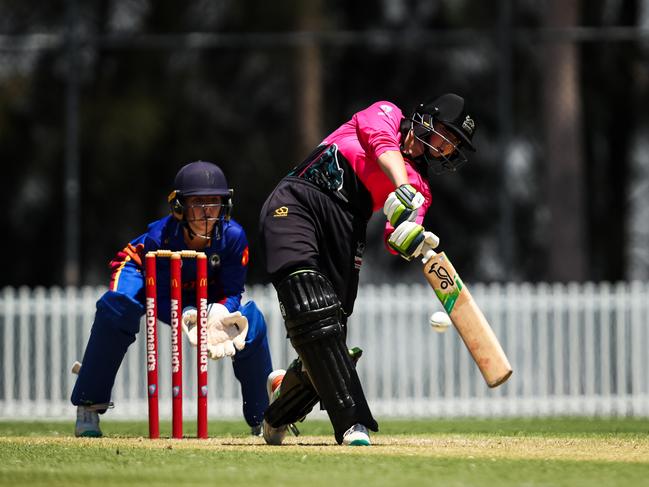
260 94 476 445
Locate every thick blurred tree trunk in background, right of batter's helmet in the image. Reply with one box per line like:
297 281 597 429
543 0 587 282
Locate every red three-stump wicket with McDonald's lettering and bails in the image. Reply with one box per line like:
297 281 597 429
145 250 208 439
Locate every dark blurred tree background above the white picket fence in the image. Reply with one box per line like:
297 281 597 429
0 0 649 286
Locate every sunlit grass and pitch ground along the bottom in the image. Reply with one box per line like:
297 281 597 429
0 419 649 487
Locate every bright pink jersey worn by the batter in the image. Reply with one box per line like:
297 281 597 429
322 101 432 250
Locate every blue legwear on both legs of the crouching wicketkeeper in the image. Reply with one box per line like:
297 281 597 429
71 291 272 426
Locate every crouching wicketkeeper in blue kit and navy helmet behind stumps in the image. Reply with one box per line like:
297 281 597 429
72 161 272 437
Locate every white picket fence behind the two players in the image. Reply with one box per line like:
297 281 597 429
0 282 649 419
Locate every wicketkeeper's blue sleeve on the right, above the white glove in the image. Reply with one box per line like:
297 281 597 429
221 221 248 312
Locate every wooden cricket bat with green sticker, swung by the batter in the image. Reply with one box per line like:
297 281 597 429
423 249 512 387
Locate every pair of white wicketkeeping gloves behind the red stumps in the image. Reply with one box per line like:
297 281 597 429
182 303 248 360
